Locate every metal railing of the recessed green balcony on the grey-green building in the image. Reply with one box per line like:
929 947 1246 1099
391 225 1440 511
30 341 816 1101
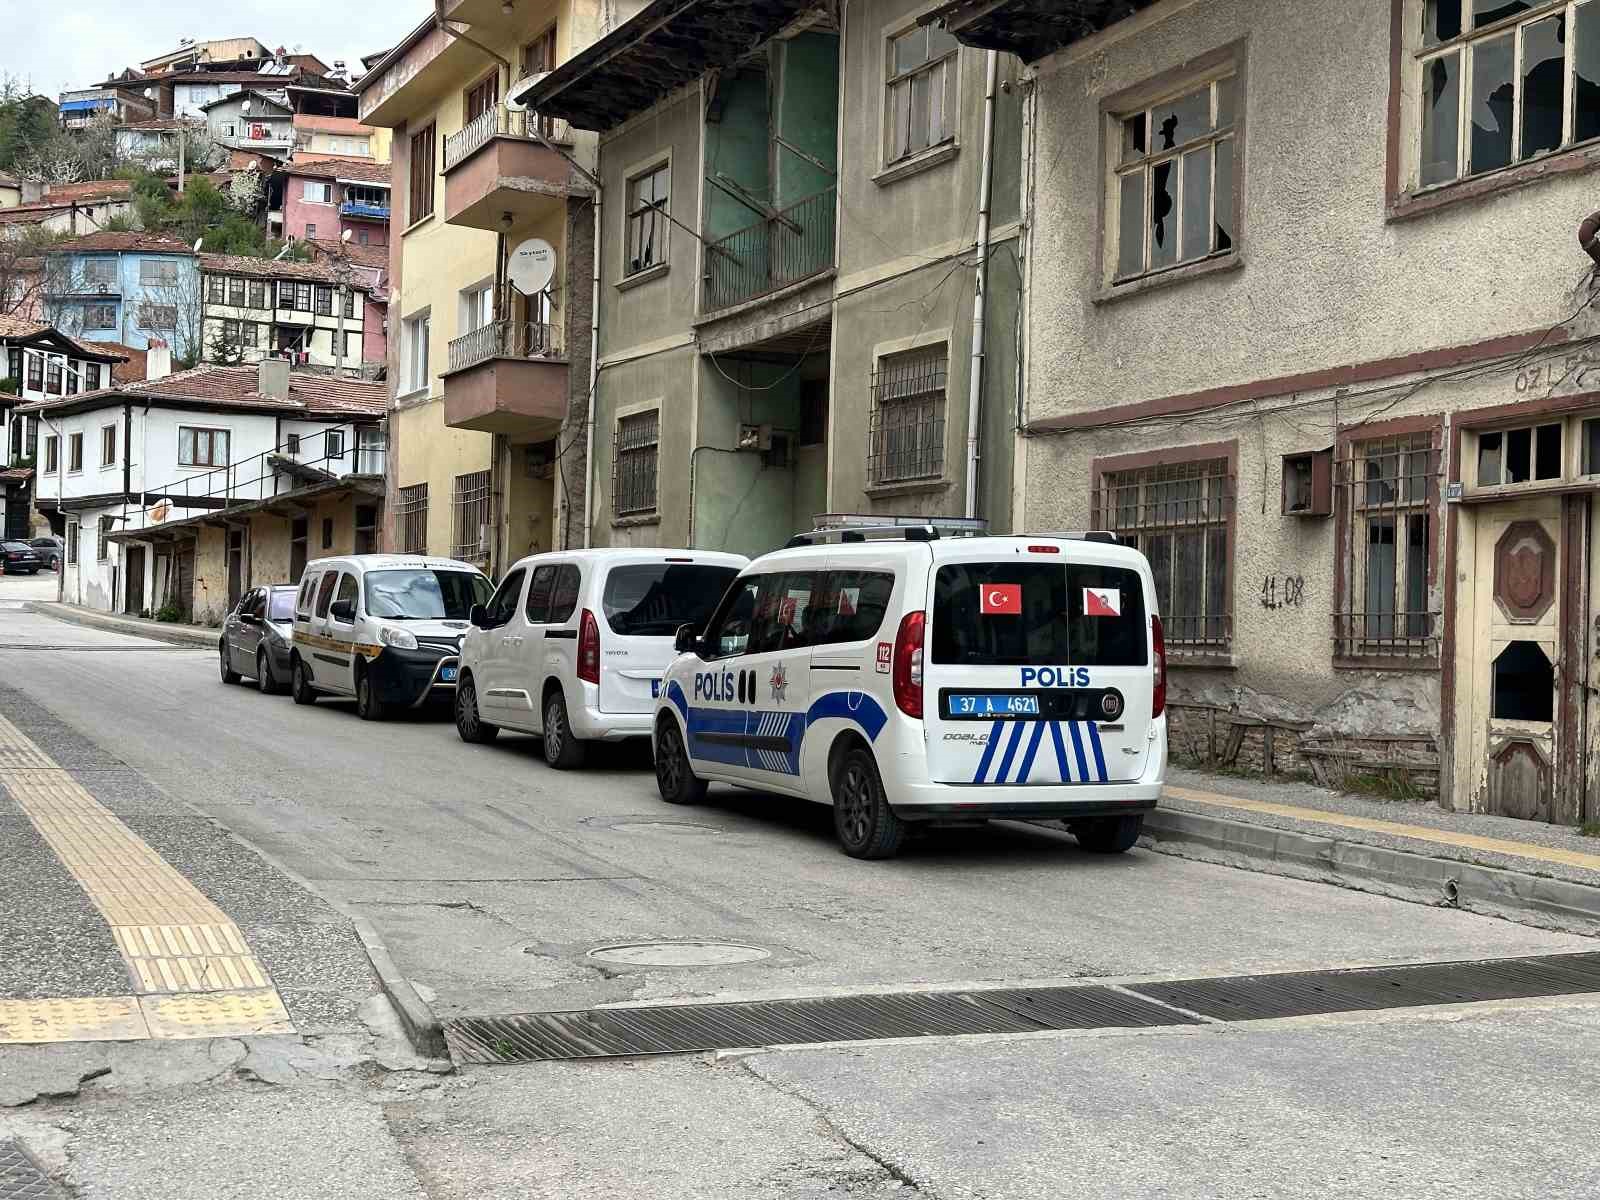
704 187 834 312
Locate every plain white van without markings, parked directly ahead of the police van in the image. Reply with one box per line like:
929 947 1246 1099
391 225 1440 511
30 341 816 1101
456 549 750 768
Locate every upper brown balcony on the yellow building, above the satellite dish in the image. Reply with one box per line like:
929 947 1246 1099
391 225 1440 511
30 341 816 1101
445 104 589 230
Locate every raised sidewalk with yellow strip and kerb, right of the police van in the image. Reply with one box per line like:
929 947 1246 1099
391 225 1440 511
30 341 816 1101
1144 768 1600 934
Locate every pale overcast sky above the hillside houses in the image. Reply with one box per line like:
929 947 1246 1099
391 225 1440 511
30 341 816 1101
0 0 432 99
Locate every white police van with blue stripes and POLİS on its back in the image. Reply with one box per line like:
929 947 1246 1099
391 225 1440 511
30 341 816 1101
654 526 1166 858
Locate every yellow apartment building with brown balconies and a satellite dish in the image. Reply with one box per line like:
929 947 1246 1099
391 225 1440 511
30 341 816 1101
355 0 617 570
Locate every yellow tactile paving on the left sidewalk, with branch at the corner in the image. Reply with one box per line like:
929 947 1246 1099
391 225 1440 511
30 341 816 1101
0 717 294 1042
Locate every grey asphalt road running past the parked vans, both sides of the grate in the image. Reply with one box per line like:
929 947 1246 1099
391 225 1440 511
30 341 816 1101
0 582 1600 1200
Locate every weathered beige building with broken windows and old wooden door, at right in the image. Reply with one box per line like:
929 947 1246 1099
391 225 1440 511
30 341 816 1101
941 0 1600 824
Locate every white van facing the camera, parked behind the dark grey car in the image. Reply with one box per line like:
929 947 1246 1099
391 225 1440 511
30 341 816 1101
290 554 493 720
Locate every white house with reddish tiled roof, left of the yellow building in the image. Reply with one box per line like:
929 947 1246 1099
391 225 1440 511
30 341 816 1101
19 355 386 624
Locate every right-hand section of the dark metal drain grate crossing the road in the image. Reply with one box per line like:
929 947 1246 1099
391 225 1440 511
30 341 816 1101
1130 954 1600 1021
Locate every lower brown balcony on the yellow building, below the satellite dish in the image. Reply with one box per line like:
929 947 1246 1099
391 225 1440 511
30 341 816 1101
445 320 566 440
